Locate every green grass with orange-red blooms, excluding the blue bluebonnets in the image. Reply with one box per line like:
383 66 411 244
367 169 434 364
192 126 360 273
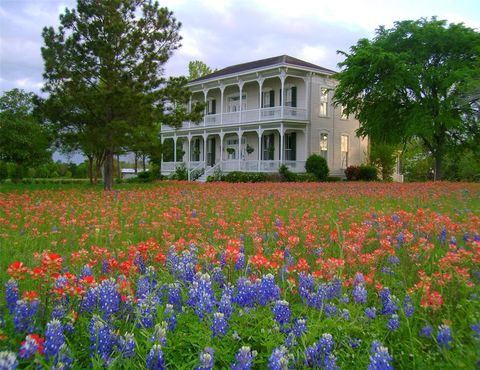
0 182 480 369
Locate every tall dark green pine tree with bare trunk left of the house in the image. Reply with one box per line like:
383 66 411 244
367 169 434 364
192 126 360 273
42 0 181 190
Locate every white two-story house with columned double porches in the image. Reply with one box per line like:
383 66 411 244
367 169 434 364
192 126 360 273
161 55 368 178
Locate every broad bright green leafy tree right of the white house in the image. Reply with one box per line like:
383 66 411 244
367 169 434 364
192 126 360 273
334 18 480 179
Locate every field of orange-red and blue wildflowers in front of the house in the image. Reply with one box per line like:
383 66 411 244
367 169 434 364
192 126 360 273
0 182 480 369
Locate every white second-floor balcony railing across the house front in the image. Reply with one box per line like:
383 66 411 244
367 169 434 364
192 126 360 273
162 107 308 132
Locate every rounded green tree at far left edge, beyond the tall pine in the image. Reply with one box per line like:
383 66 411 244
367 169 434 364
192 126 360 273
0 89 52 166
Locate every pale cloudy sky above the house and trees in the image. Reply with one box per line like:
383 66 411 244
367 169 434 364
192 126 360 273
0 0 480 93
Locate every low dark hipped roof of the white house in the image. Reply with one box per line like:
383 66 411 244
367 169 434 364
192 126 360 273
190 55 336 83
